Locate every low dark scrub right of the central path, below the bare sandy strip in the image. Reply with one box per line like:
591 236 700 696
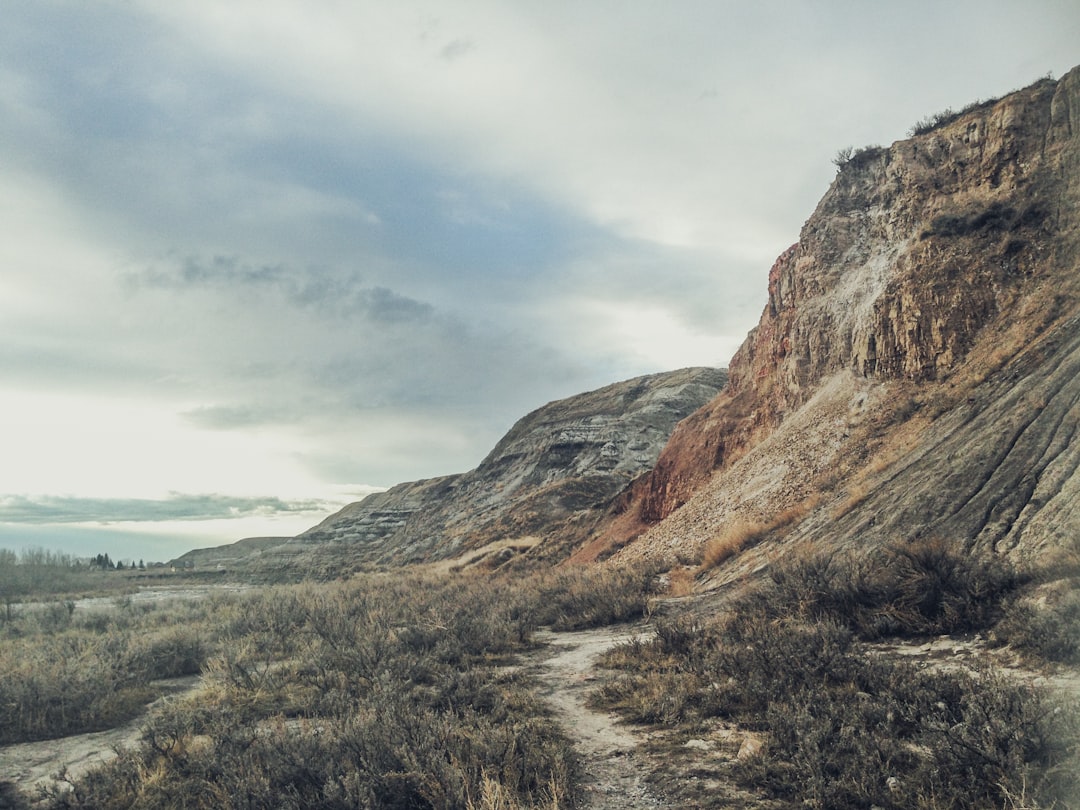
595 612 1080 810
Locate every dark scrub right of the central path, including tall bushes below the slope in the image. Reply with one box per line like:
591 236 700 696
593 541 1080 810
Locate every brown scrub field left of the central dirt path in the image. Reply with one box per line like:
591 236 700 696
0 568 659 810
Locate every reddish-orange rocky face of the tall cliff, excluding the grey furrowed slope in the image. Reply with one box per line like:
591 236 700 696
579 69 1080 559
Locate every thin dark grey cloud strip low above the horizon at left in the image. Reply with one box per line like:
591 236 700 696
0 492 330 525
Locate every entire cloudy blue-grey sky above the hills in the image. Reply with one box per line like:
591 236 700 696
0 0 1080 561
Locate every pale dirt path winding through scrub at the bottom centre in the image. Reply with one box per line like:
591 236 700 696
530 627 663 810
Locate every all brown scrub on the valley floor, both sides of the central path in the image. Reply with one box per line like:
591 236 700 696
0 540 1080 810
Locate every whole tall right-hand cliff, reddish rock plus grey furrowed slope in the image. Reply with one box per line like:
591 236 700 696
591 68 1080 559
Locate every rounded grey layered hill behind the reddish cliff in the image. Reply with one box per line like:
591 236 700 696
294 368 727 565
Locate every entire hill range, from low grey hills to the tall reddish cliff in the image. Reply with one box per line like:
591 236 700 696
190 68 1080 583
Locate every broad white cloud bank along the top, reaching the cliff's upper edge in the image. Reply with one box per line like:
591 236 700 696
135 1 1077 257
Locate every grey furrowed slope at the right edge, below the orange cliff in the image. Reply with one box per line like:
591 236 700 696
820 315 1080 556
